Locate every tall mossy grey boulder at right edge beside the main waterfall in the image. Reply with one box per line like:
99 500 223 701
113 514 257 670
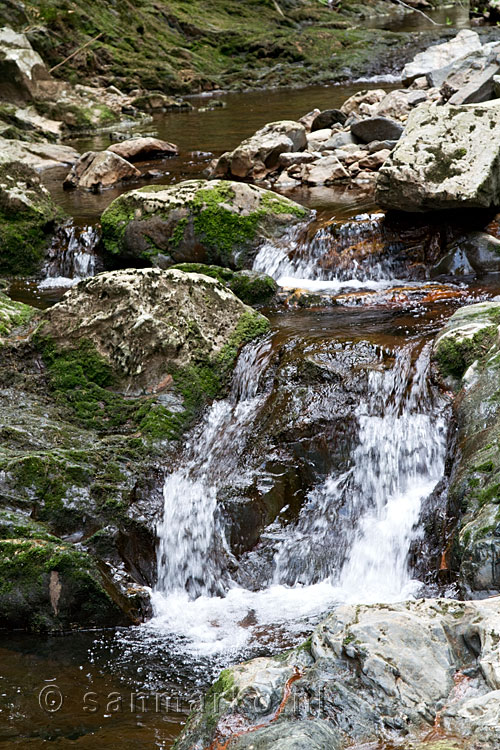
434 301 500 596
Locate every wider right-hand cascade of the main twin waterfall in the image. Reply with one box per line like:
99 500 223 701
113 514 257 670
274 346 446 601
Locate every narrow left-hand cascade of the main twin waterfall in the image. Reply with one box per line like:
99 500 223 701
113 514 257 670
156 338 272 598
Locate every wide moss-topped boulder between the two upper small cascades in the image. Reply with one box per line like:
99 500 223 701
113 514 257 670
101 180 311 268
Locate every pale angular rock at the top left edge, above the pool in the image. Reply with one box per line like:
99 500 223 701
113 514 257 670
0 26 57 102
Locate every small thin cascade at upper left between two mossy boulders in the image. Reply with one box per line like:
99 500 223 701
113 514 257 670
39 222 103 289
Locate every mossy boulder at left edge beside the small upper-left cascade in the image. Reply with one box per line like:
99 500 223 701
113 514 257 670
0 162 62 274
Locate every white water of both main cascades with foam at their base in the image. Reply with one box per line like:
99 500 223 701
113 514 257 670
150 334 446 657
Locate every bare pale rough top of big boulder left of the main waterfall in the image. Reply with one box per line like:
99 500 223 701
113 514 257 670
44 268 268 398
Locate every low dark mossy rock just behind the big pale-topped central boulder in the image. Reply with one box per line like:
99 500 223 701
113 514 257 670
172 263 278 305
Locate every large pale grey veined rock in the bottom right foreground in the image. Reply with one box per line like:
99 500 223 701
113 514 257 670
177 597 500 750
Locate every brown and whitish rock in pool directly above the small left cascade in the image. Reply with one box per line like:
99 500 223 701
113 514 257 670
63 151 141 191
